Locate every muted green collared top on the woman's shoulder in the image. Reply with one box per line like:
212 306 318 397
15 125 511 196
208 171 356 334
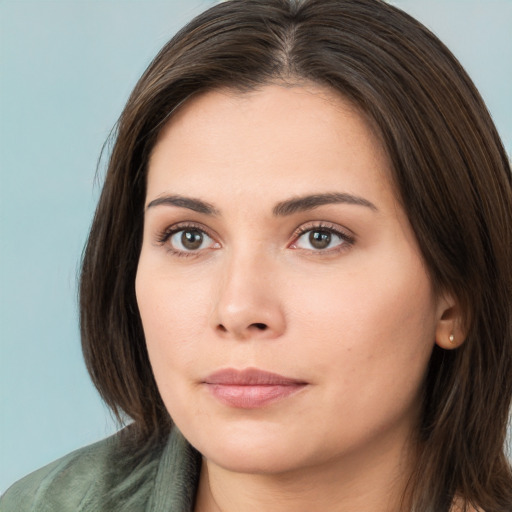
0 428 201 512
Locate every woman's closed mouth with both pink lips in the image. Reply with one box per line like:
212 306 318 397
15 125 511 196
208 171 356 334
203 368 308 409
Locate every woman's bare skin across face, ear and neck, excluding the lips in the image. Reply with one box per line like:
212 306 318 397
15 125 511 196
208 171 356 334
136 84 456 512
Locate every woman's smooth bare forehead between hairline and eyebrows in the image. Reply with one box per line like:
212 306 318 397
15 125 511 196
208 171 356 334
148 85 393 210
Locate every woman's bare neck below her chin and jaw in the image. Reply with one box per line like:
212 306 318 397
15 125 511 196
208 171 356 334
195 432 412 512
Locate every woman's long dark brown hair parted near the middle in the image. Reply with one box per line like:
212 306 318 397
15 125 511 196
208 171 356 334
80 0 512 512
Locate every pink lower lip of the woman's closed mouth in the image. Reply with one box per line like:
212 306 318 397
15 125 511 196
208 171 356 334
206 384 306 409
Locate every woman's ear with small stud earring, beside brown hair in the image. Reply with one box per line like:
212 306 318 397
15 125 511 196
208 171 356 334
436 293 466 350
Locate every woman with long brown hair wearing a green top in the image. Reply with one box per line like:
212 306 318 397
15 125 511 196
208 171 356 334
1 0 512 512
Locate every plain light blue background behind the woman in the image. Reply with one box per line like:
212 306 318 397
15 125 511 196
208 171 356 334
0 0 512 491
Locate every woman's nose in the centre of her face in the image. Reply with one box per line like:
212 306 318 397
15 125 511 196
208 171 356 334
212 249 286 340
